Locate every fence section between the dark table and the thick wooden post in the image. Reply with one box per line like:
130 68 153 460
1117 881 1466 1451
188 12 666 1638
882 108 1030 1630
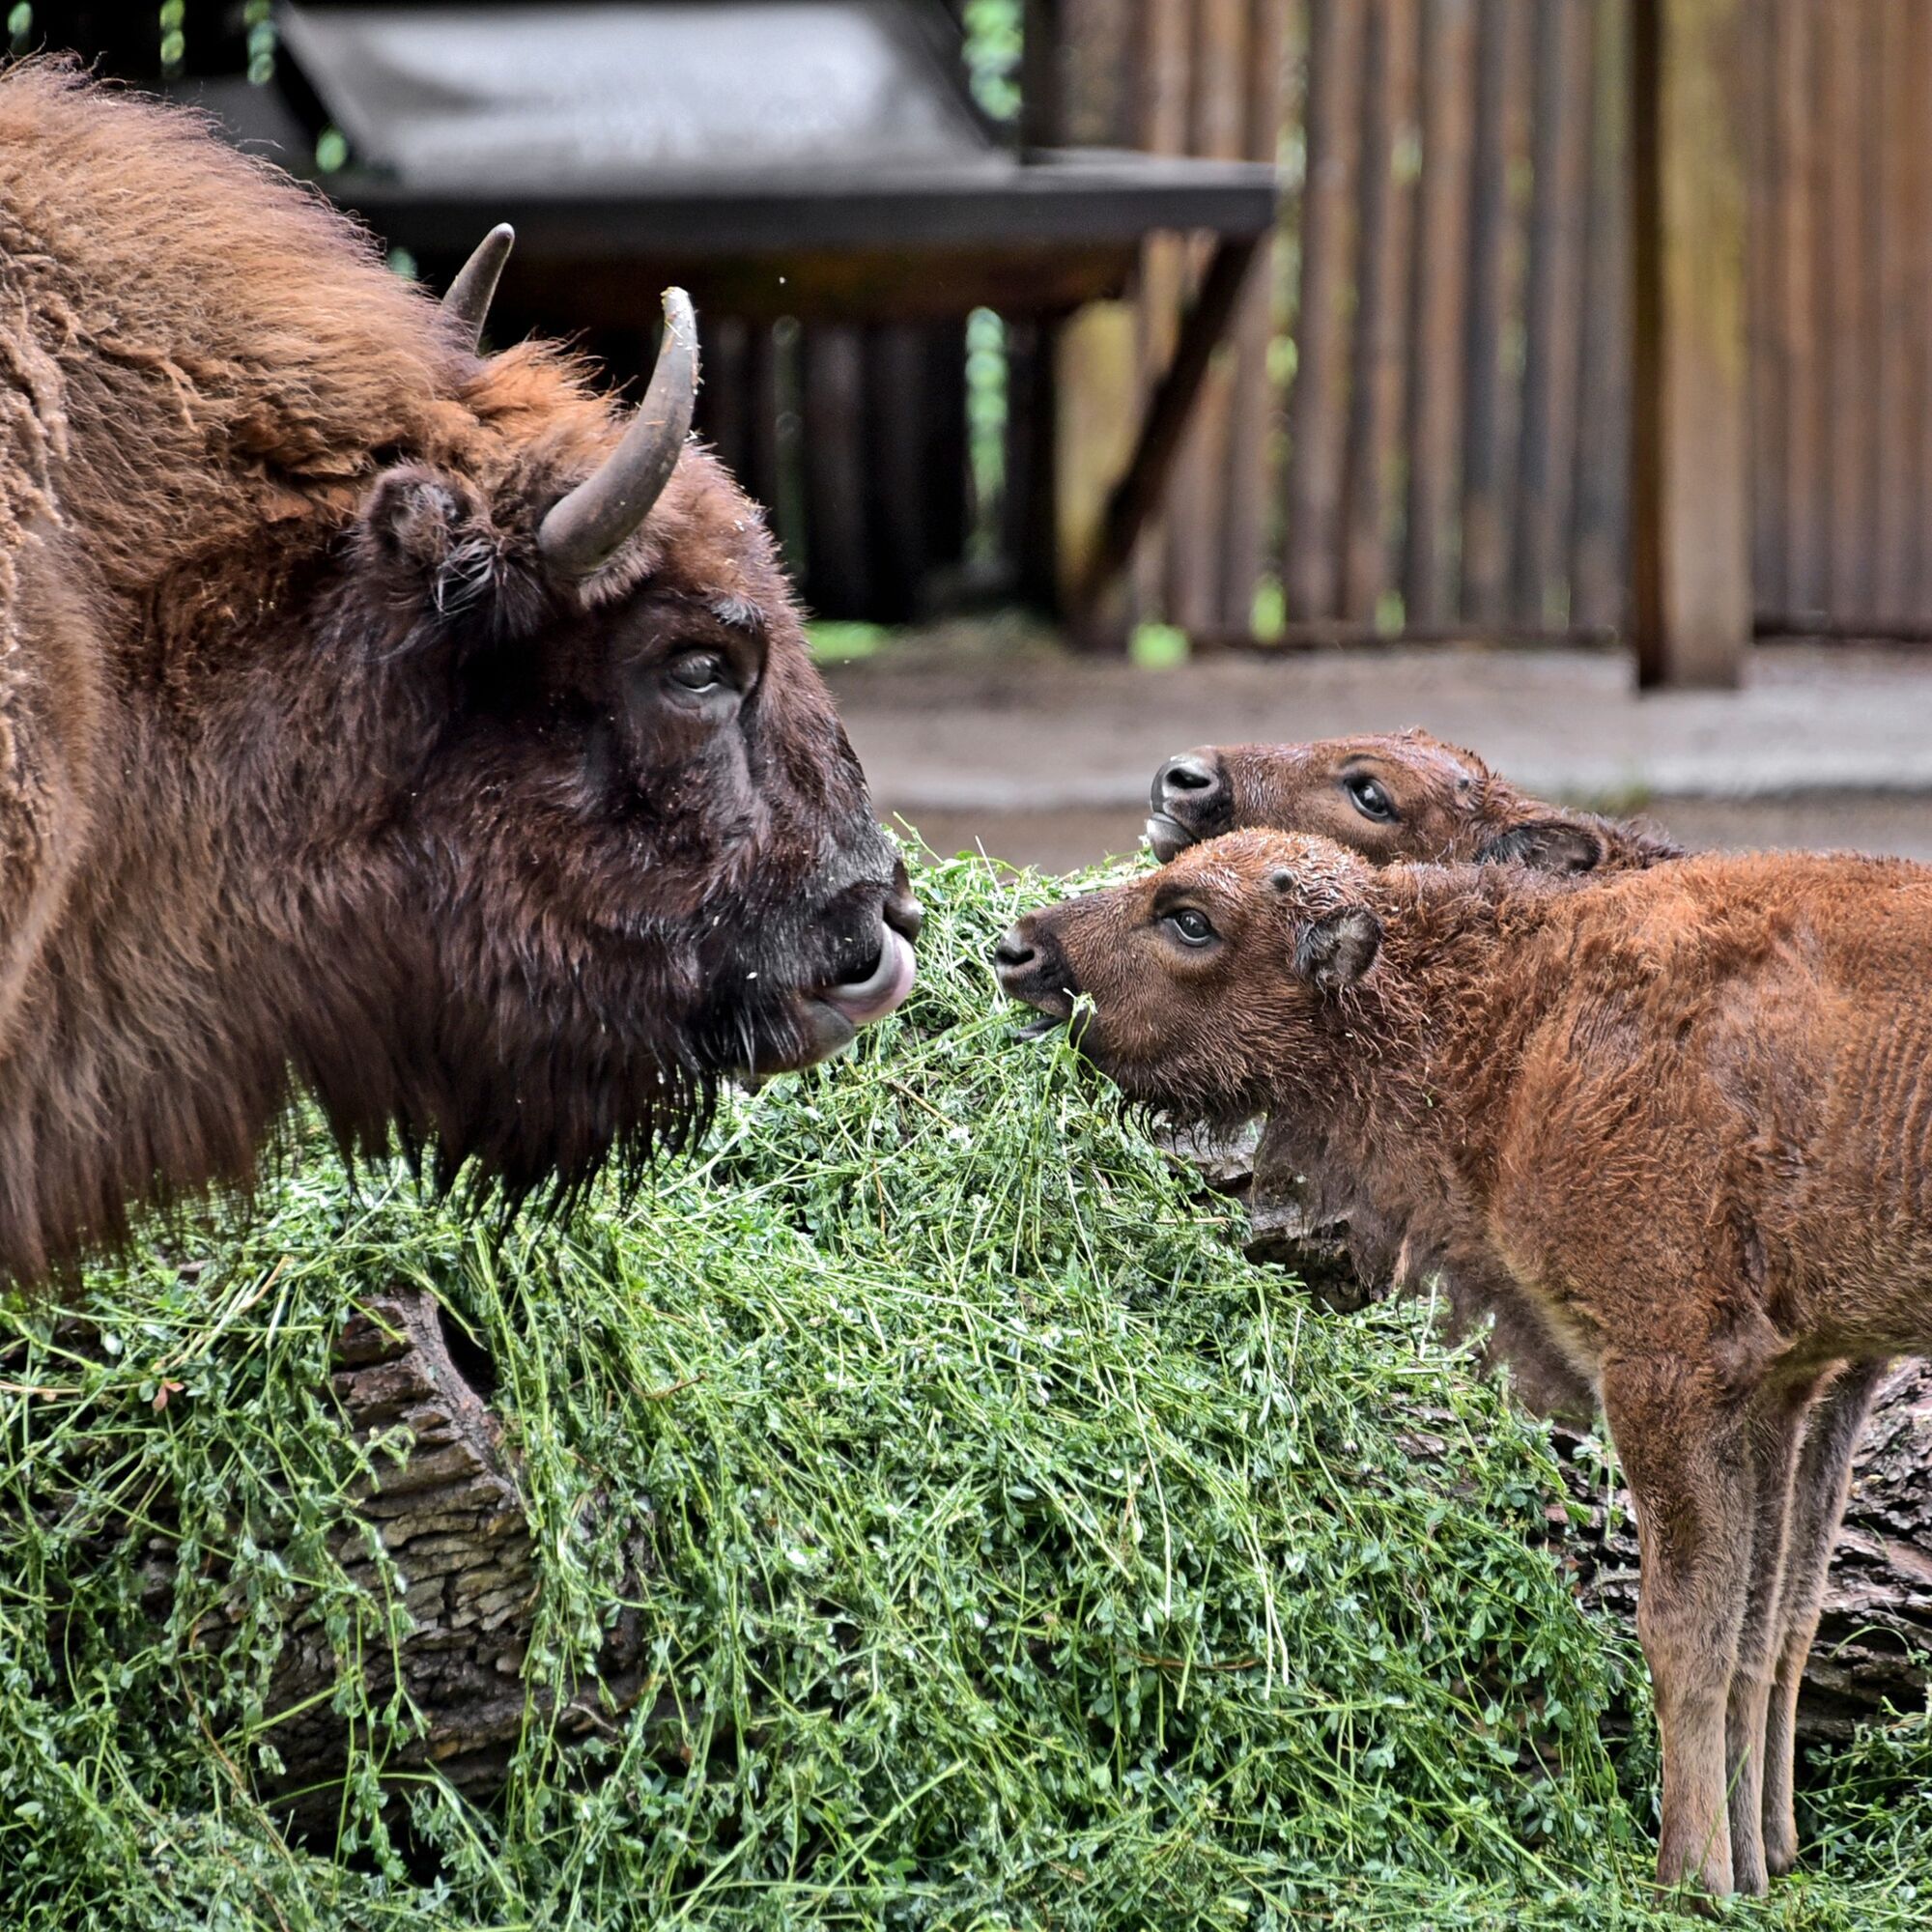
1063 0 1629 638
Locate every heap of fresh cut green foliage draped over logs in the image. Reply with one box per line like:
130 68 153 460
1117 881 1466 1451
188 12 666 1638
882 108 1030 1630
0 860 1932 1932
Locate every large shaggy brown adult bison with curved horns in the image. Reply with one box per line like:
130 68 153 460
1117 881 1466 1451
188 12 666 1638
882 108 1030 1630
0 64 918 1281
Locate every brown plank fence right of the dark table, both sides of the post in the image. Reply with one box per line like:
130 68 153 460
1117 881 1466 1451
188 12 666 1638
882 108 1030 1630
1055 0 1932 639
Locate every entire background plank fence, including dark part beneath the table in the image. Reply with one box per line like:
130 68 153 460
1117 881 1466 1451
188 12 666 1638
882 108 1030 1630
33 0 1932 639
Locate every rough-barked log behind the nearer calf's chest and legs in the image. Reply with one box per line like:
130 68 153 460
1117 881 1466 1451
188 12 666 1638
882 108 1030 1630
1175 1132 1932 1743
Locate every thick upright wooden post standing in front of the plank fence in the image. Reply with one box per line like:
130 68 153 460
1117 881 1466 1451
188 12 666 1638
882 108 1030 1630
1631 0 1750 686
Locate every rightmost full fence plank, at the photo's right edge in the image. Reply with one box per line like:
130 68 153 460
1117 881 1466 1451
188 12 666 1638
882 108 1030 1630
1872 0 1924 624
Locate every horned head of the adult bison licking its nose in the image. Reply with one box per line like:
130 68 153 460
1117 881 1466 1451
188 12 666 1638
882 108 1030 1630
311 270 920 1194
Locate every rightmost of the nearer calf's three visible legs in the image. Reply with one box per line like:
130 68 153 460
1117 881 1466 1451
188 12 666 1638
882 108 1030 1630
1764 1360 1889 1874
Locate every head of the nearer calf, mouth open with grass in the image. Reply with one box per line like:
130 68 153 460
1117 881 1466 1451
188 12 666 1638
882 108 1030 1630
995 831 1381 1124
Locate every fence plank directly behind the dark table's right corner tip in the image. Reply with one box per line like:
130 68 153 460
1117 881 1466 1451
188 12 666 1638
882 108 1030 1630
1221 0 1289 630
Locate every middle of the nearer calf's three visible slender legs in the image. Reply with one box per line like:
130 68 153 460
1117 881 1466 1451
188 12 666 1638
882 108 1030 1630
1723 1379 1816 1895
